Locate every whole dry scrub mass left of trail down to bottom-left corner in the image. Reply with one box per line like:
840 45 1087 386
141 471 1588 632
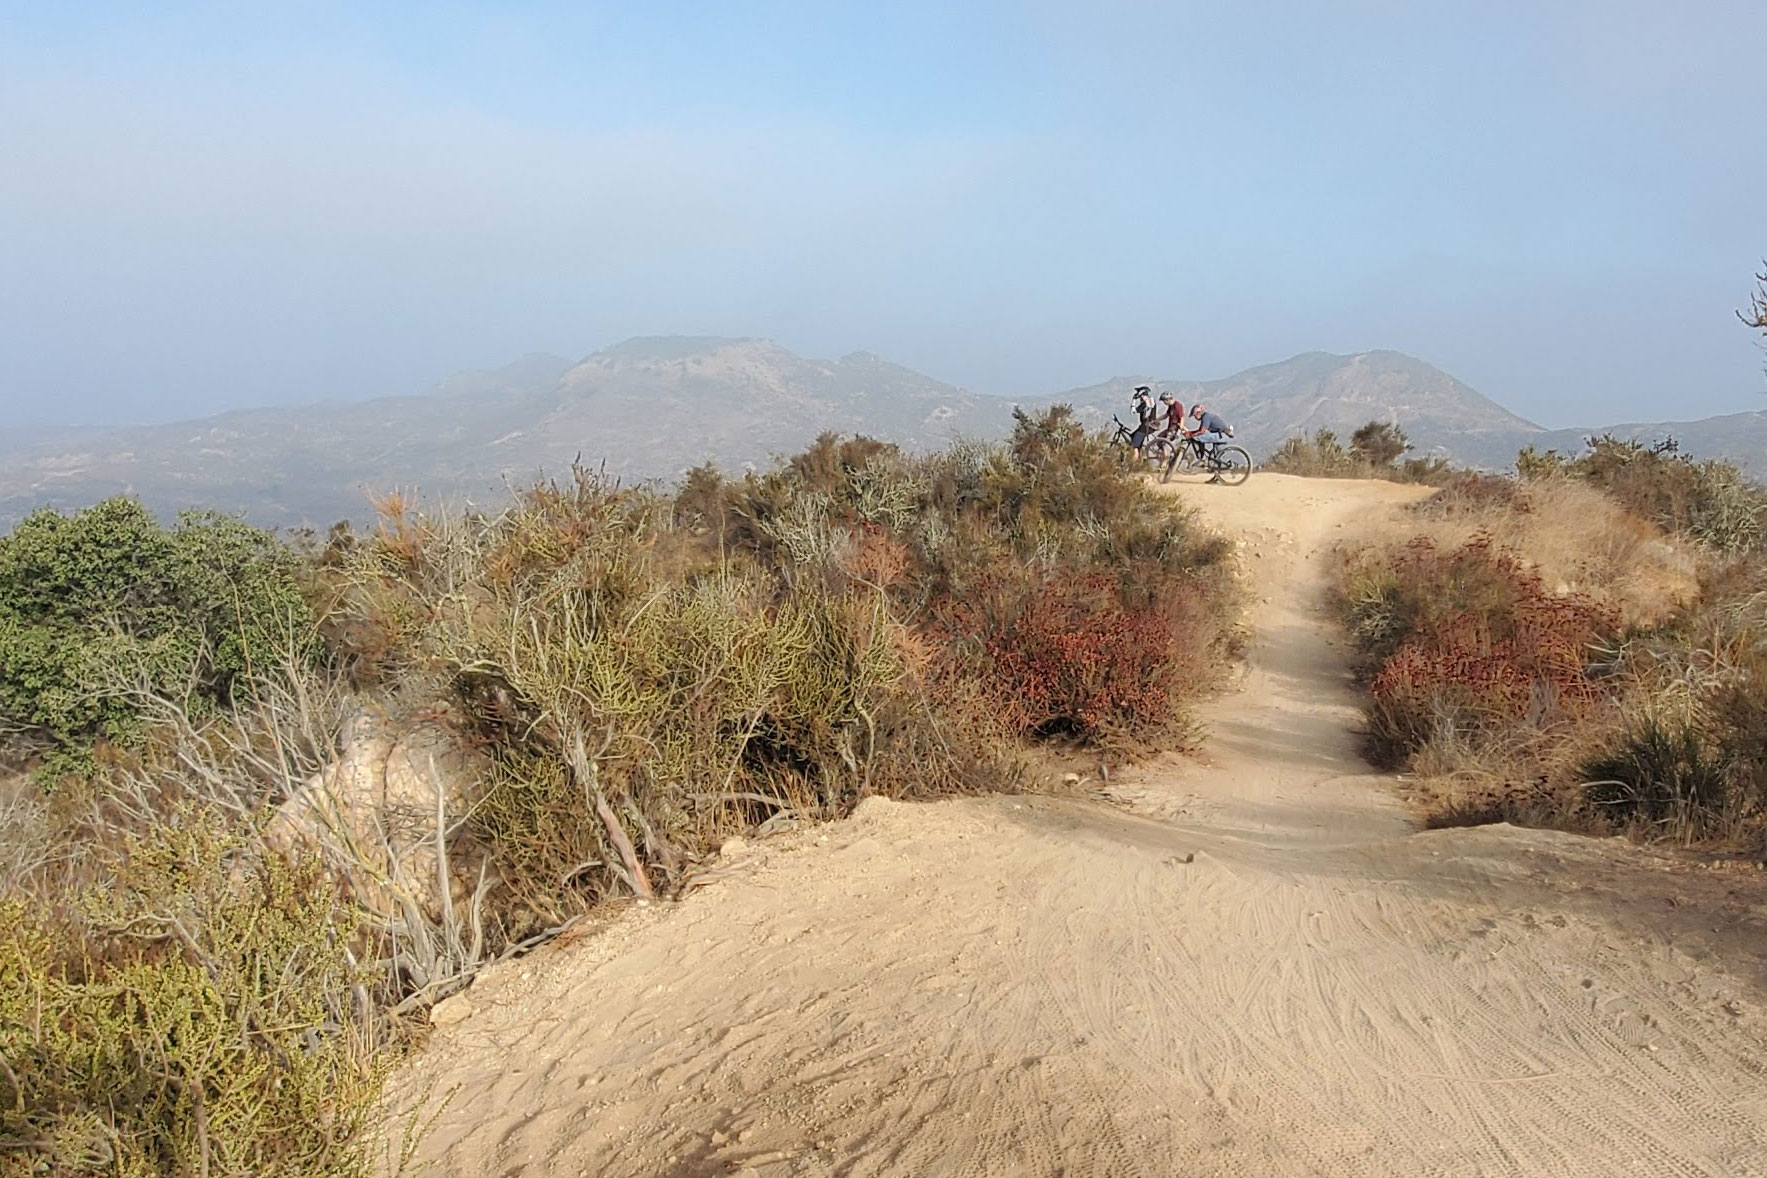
0 410 1239 1174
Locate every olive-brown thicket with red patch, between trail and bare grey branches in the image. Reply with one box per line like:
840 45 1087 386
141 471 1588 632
318 410 1235 952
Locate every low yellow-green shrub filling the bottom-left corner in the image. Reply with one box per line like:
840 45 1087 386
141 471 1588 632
0 811 380 1178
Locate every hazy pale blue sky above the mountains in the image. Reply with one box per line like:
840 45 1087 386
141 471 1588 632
0 0 1767 427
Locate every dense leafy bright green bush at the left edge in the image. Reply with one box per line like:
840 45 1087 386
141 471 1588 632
0 498 313 756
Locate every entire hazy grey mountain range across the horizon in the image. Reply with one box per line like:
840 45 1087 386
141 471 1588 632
0 337 1767 526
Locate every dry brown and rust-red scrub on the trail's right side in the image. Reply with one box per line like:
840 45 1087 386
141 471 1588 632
1339 466 1767 846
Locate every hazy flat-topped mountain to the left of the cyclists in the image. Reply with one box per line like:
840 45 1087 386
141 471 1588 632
0 337 1004 526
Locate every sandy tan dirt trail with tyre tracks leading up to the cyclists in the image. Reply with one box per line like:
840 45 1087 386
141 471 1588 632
399 475 1767 1178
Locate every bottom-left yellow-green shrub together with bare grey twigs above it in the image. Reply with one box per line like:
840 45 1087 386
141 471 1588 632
0 646 434 1176
